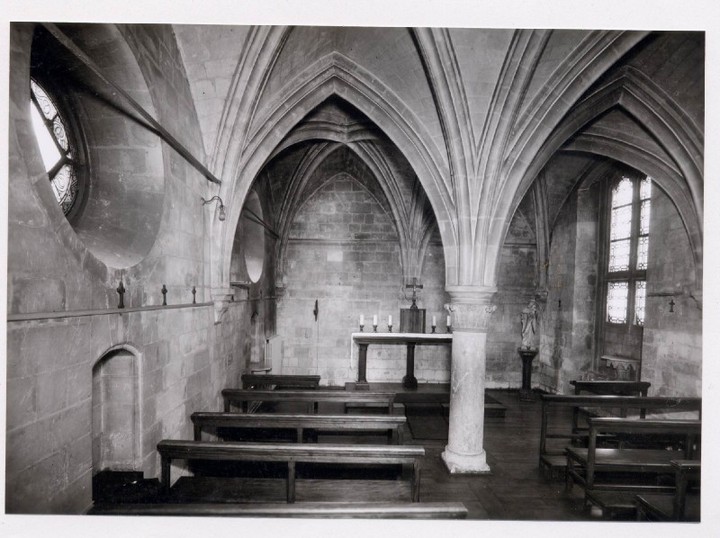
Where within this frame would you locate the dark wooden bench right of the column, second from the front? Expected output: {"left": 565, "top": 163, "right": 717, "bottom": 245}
{"left": 565, "top": 417, "right": 701, "bottom": 498}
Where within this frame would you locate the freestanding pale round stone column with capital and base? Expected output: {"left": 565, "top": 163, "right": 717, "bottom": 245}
{"left": 442, "top": 286, "right": 497, "bottom": 473}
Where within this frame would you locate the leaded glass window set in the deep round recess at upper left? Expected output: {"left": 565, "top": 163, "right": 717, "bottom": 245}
{"left": 30, "top": 79, "right": 79, "bottom": 215}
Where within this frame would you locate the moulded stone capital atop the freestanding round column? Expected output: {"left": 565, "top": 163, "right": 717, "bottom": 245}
{"left": 445, "top": 286, "right": 497, "bottom": 332}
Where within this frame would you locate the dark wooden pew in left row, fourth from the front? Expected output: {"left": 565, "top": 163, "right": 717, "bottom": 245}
{"left": 222, "top": 389, "right": 395, "bottom": 415}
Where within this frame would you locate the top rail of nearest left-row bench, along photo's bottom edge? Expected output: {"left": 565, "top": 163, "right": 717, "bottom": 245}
{"left": 88, "top": 502, "right": 468, "bottom": 519}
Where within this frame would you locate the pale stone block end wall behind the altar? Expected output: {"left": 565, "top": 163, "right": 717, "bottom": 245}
{"left": 277, "top": 174, "right": 450, "bottom": 385}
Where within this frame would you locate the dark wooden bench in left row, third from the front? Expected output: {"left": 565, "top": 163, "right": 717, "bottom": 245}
{"left": 190, "top": 412, "right": 407, "bottom": 444}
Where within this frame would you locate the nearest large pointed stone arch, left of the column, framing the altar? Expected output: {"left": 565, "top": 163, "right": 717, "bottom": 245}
{"left": 210, "top": 52, "right": 457, "bottom": 288}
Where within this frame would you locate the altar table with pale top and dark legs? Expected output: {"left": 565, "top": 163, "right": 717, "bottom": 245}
{"left": 352, "top": 332, "right": 452, "bottom": 390}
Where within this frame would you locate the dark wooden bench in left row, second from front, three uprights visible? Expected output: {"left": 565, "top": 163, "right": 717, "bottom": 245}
{"left": 157, "top": 440, "right": 425, "bottom": 503}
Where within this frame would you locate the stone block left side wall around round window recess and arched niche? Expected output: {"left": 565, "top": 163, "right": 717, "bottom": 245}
{"left": 6, "top": 24, "right": 262, "bottom": 513}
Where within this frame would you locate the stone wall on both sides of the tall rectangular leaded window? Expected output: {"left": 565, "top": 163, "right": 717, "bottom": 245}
{"left": 538, "top": 172, "right": 702, "bottom": 396}
